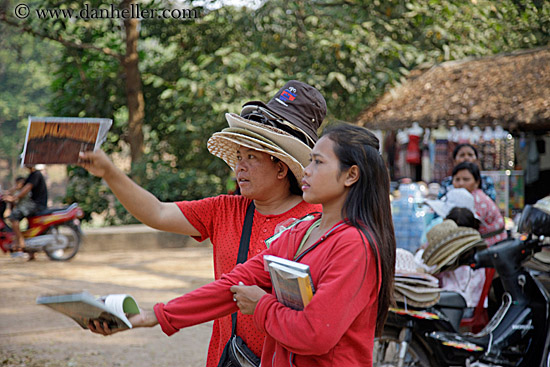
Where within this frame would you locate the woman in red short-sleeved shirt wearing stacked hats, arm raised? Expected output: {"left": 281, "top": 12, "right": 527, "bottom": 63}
{"left": 81, "top": 80, "right": 326, "bottom": 367}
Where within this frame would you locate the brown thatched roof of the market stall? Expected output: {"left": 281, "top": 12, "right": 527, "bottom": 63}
{"left": 356, "top": 48, "right": 550, "bottom": 131}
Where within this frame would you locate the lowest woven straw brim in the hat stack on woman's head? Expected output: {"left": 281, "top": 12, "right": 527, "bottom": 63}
{"left": 207, "top": 132, "right": 304, "bottom": 182}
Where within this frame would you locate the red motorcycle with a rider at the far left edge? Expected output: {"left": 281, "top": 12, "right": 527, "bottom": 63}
{"left": 0, "top": 198, "right": 84, "bottom": 261}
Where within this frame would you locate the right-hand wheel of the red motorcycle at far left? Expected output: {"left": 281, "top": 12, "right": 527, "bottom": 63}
{"left": 44, "top": 223, "right": 82, "bottom": 261}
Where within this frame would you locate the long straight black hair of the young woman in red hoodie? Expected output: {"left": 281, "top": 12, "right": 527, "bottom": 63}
{"left": 323, "top": 124, "right": 395, "bottom": 336}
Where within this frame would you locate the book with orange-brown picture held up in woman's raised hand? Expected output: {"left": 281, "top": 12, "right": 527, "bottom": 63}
{"left": 21, "top": 116, "right": 113, "bottom": 166}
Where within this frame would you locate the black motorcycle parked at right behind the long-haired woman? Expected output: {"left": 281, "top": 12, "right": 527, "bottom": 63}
{"left": 373, "top": 205, "right": 550, "bottom": 367}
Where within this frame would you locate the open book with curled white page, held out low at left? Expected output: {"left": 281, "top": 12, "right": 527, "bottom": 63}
{"left": 36, "top": 292, "right": 139, "bottom": 329}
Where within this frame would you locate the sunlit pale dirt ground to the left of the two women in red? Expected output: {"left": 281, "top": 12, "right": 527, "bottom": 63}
{"left": 0, "top": 246, "right": 213, "bottom": 367}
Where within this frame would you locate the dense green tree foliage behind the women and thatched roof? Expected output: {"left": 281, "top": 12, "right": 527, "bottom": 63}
{"left": 0, "top": 0, "right": 550, "bottom": 223}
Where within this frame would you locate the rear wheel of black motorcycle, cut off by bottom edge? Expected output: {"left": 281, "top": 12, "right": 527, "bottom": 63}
{"left": 372, "top": 326, "right": 435, "bottom": 367}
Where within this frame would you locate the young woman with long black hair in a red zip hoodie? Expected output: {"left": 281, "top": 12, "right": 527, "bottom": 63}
{"left": 90, "top": 125, "right": 395, "bottom": 367}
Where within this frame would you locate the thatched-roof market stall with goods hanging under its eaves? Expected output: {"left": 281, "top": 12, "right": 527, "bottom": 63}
{"left": 356, "top": 47, "right": 550, "bottom": 250}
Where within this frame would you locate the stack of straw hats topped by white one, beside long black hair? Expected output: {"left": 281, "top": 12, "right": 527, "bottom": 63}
{"left": 393, "top": 248, "right": 441, "bottom": 308}
